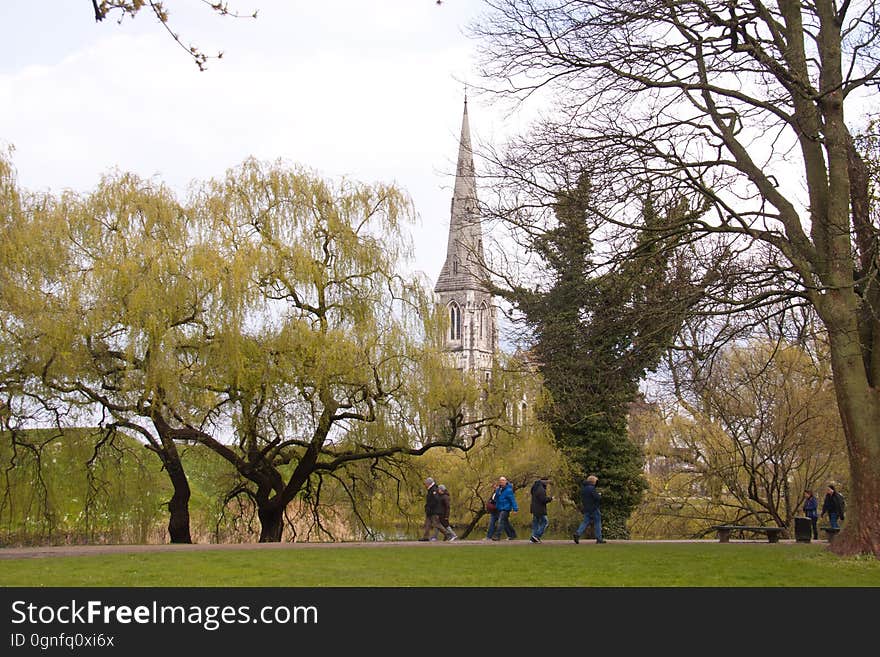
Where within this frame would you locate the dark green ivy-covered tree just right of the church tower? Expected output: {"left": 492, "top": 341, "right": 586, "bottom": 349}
{"left": 499, "top": 174, "right": 693, "bottom": 536}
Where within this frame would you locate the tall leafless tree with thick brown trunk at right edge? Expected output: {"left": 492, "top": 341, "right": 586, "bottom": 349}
{"left": 474, "top": 0, "right": 880, "bottom": 556}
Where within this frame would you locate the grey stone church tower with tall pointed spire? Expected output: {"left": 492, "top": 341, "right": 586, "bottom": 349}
{"left": 434, "top": 98, "right": 498, "bottom": 374}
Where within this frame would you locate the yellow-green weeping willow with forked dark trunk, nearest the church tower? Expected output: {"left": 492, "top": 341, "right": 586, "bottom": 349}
{"left": 183, "top": 160, "right": 497, "bottom": 542}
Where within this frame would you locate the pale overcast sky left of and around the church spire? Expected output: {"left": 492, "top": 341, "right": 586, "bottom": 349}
{"left": 0, "top": 0, "right": 524, "bottom": 282}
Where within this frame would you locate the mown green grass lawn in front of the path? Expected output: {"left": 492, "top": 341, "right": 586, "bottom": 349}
{"left": 0, "top": 542, "right": 880, "bottom": 587}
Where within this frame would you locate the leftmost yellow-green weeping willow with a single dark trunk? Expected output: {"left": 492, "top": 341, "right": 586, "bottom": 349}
{"left": 0, "top": 160, "right": 215, "bottom": 543}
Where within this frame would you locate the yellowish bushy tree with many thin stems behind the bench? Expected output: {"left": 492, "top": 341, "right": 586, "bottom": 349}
{"left": 639, "top": 336, "right": 848, "bottom": 534}
